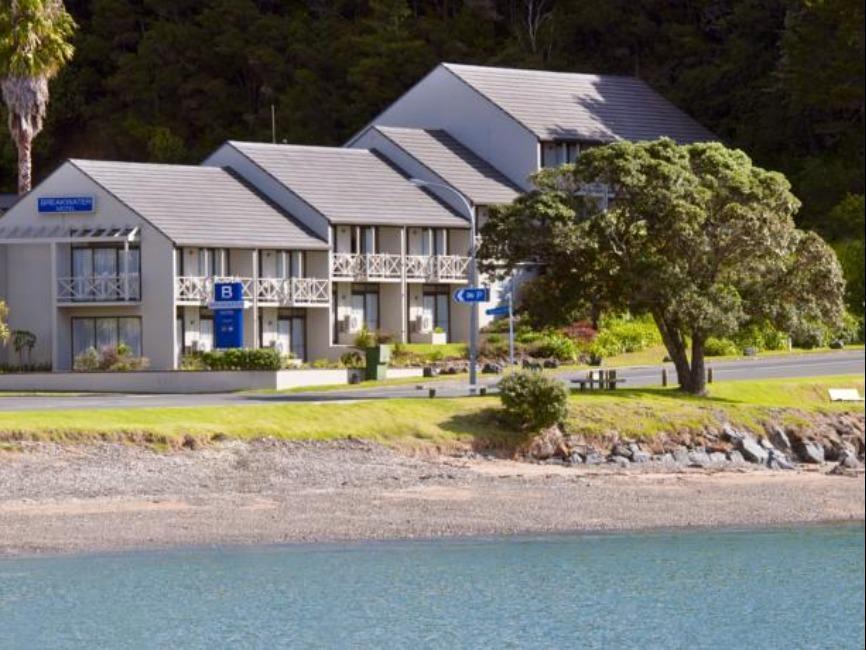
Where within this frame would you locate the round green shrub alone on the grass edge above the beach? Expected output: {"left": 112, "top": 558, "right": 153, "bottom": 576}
{"left": 499, "top": 371, "right": 568, "bottom": 431}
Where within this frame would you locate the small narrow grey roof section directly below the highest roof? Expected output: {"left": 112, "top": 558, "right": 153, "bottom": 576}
{"left": 373, "top": 126, "right": 520, "bottom": 205}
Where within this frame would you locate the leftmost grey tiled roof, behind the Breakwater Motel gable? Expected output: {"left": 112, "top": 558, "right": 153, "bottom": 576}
{"left": 69, "top": 160, "right": 327, "bottom": 249}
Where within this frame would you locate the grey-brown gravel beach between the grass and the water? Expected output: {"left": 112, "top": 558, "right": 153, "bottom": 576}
{"left": 0, "top": 440, "right": 864, "bottom": 555}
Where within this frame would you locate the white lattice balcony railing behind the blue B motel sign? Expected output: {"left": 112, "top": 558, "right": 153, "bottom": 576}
{"left": 175, "top": 276, "right": 331, "bottom": 307}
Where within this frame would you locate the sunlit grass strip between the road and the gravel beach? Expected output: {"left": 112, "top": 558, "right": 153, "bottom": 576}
{"left": 0, "top": 375, "right": 864, "bottom": 448}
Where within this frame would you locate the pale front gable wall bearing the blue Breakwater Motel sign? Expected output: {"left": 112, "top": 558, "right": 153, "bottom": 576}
{"left": 0, "top": 163, "right": 175, "bottom": 370}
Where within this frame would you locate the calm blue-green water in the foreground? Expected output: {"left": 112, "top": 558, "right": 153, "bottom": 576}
{"left": 0, "top": 526, "right": 864, "bottom": 650}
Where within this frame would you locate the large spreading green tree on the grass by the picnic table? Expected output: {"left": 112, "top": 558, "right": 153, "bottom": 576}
{"left": 480, "top": 139, "right": 845, "bottom": 394}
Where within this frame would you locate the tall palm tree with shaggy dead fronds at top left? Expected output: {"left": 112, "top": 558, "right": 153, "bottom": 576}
{"left": 0, "top": 0, "right": 75, "bottom": 194}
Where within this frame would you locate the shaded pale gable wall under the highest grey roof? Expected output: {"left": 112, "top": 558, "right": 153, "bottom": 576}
{"left": 347, "top": 66, "right": 540, "bottom": 190}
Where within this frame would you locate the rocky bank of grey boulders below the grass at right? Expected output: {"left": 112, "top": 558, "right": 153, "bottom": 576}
{"left": 502, "top": 413, "right": 866, "bottom": 474}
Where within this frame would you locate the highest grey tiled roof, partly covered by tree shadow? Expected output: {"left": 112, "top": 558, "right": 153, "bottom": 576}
{"left": 442, "top": 63, "right": 718, "bottom": 143}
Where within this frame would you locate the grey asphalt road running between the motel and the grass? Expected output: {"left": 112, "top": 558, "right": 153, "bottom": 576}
{"left": 0, "top": 350, "right": 866, "bottom": 411}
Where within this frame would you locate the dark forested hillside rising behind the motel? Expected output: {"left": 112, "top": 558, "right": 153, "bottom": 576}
{"left": 0, "top": 0, "right": 864, "bottom": 246}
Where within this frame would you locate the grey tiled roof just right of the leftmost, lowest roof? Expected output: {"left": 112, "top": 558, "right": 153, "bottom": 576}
{"left": 228, "top": 142, "right": 467, "bottom": 227}
